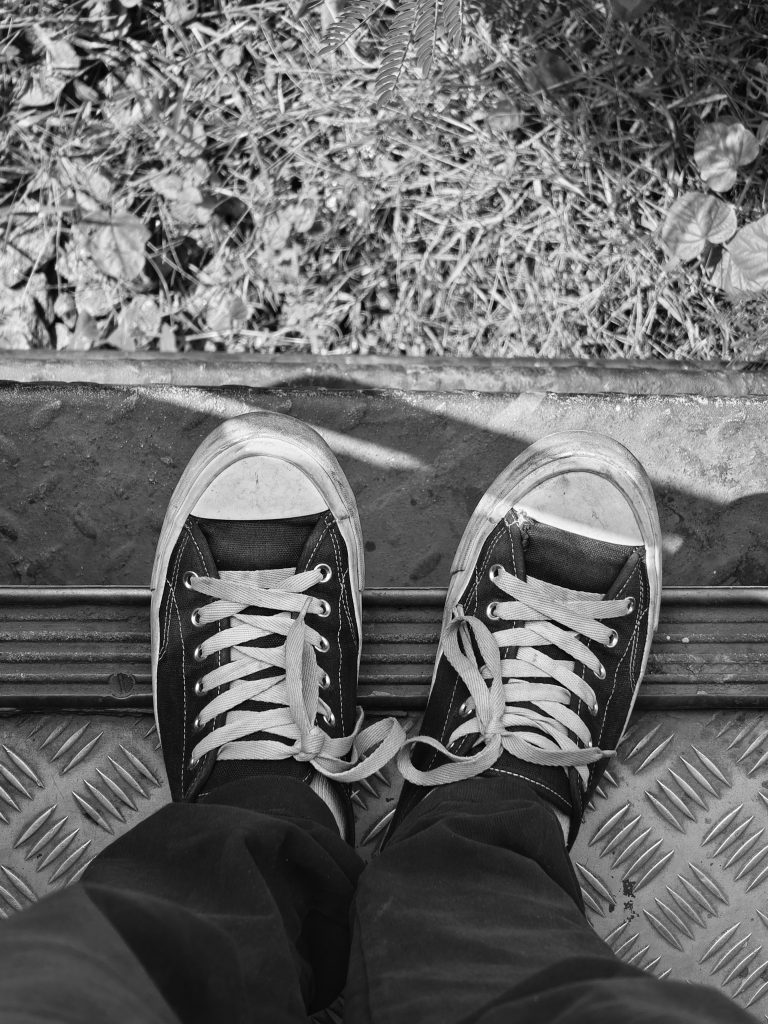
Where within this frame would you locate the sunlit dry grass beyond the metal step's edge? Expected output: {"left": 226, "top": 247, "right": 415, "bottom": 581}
{"left": 0, "top": 0, "right": 768, "bottom": 364}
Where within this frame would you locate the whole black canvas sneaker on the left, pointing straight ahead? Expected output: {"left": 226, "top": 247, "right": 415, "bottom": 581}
{"left": 146, "top": 413, "right": 406, "bottom": 842}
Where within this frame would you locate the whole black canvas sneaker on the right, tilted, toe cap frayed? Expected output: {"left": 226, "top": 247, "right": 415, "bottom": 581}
{"left": 388, "top": 431, "right": 662, "bottom": 849}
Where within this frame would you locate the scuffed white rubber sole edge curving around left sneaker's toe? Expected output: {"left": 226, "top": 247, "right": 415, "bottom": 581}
{"left": 150, "top": 412, "right": 366, "bottom": 734}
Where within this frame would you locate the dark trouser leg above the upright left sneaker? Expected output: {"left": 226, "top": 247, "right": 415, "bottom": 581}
{"left": 0, "top": 776, "right": 362, "bottom": 1024}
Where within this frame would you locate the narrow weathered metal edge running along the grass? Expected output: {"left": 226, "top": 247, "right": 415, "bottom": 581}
{"left": 0, "top": 350, "right": 768, "bottom": 397}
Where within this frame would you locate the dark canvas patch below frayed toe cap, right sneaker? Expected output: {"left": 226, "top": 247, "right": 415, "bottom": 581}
{"left": 519, "top": 517, "right": 634, "bottom": 594}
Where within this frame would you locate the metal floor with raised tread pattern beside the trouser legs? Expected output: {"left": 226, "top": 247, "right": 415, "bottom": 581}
{"left": 0, "top": 711, "right": 768, "bottom": 1021}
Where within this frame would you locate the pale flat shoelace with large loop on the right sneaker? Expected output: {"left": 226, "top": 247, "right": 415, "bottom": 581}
{"left": 397, "top": 565, "right": 635, "bottom": 787}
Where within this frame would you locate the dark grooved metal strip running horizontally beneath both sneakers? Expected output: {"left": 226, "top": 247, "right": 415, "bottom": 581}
{"left": 0, "top": 587, "right": 768, "bottom": 711}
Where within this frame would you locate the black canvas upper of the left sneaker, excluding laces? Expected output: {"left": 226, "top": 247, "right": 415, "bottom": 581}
{"left": 157, "top": 511, "right": 360, "bottom": 834}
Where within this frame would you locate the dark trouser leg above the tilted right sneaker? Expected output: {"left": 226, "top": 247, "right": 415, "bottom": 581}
{"left": 346, "top": 778, "right": 752, "bottom": 1024}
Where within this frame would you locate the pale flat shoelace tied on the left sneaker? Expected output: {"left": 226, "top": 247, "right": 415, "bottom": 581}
{"left": 186, "top": 565, "right": 406, "bottom": 782}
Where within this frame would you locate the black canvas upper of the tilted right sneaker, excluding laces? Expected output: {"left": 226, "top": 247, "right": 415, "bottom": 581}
{"left": 389, "top": 509, "right": 650, "bottom": 845}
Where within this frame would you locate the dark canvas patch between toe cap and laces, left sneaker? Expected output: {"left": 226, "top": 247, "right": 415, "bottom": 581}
{"left": 191, "top": 513, "right": 322, "bottom": 573}
